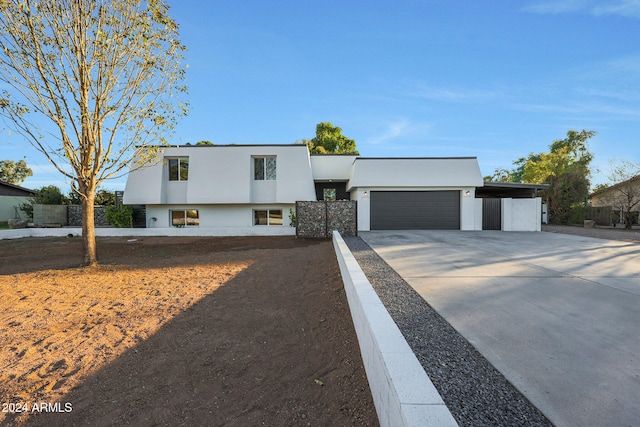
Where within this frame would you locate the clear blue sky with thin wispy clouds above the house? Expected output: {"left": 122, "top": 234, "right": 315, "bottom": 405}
{"left": 0, "top": 0, "right": 640, "bottom": 190}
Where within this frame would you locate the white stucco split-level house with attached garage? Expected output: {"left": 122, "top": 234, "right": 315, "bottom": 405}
{"left": 123, "top": 144, "right": 540, "bottom": 235}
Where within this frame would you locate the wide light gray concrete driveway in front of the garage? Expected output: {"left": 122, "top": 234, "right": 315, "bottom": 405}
{"left": 360, "top": 231, "right": 640, "bottom": 426}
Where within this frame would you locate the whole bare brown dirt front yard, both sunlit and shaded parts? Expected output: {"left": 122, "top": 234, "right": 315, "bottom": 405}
{"left": 0, "top": 237, "right": 378, "bottom": 426}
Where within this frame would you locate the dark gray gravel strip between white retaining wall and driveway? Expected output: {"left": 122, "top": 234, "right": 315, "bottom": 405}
{"left": 344, "top": 237, "right": 553, "bottom": 427}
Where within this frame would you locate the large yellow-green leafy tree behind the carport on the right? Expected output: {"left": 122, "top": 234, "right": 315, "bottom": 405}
{"left": 512, "top": 130, "right": 596, "bottom": 223}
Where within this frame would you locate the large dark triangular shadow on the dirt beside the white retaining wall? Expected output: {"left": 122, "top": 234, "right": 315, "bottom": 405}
{"left": 5, "top": 241, "right": 377, "bottom": 426}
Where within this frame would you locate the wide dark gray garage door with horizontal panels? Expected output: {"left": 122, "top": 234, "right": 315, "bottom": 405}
{"left": 371, "top": 191, "right": 460, "bottom": 230}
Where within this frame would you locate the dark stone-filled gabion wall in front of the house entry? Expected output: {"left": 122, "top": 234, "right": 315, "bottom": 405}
{"left": 296, "top": 200, "right": 358, "bottom": 239}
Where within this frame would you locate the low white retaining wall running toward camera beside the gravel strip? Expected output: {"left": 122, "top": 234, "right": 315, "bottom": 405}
{"left": 333, "top": 231, "right": 458, "bottom": 427}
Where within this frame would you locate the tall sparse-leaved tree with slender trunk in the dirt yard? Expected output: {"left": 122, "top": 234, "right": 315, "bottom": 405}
{"left": 0, "top": 0, "right": 186, "bottom": 265}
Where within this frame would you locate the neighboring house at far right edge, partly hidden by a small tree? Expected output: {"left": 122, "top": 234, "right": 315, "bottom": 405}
{"left": 590, "top": 175, "right": 640, "bottom": 224}
